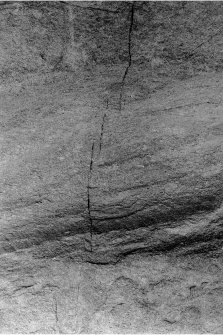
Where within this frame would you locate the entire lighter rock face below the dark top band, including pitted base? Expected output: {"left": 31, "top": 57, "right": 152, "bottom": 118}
{"left": 0, "top": 68, "right": 223, "bottom": 333}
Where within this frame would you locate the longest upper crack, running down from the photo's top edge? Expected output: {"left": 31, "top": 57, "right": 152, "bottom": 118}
{"left": 119, "top": 1, "right": 135, "bottom": 111}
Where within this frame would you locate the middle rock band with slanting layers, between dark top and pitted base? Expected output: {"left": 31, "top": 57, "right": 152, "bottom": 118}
{"left": 1, "top": 69, "right": 223, "bottom": 261}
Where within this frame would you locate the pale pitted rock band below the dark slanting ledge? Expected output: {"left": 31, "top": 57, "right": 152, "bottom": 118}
{"left": 0, "top": 251, "right": 223, "bottom": 334}
